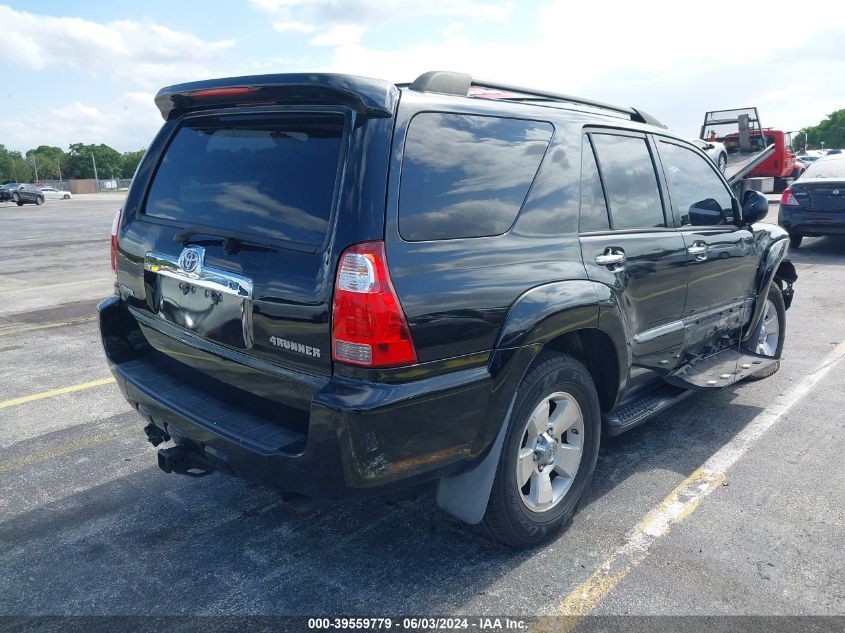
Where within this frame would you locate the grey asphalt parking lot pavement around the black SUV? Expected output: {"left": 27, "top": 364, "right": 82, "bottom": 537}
{"left": 0, "top": 194, "right": 845, "bottom": 627}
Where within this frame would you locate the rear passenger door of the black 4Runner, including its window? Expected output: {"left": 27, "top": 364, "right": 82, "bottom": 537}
{"left": 579, "top": 131, "right": 687, "bottom": 390}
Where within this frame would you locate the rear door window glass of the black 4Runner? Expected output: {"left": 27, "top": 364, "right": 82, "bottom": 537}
{"left": 592, "top": 134, "right": 666, "bottom": 229}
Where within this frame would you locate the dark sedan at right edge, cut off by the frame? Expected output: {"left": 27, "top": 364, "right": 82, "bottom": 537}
{"left": 778, "top": 154, "right": 845, "bottom": 248}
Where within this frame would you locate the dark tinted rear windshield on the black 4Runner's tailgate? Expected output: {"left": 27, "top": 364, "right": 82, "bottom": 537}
{"left": 145, "top": 113, "right": 344, "bottom": 247}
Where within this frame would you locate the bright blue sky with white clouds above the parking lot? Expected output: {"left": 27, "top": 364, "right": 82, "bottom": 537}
{"left": 0, "top": 0, "right": 845, "bottom": 151}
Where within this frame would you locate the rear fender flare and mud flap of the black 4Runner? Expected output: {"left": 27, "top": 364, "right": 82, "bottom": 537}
{"left": 436, "top": 279, "right": 617, "bottom": 525}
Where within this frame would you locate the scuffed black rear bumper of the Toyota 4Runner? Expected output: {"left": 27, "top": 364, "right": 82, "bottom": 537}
{"left": 98, "top": 296, "right": 492, "bottom": 499}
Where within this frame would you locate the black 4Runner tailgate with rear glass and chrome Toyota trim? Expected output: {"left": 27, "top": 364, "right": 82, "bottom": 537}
{"left": 125, "top": 109, "right": 349, "bottom": 375}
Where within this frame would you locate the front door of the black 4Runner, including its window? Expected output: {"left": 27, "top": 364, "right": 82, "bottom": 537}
{"left": 656, "top": 138, "right": 757, "bottom": 356}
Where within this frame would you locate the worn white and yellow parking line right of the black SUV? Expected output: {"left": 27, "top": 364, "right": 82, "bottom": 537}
{"left": 537, "top": 341, "right": 845, "bottom": 631}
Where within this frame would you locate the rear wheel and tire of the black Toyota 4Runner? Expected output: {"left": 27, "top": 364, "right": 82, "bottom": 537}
{"left": 480, "top": 352, "right": 601, "bottom": 547}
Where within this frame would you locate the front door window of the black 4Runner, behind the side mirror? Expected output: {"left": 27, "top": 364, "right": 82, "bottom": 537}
{"left": 660, "top": 141, "right": 734, "bottom": 226}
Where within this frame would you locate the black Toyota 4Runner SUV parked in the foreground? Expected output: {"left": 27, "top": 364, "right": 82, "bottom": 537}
{"left": 99, "top": 72, "right": 796, "bottom": 545}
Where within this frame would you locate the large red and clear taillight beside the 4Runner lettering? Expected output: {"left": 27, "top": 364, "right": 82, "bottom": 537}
{"left": 332, "top": 242, "right": 417, "bottom": 367}
